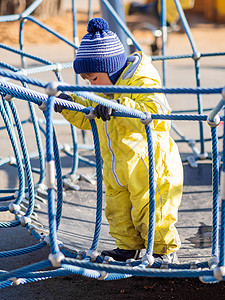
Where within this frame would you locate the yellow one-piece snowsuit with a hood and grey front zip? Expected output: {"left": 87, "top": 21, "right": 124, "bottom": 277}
{"left": 62, "top": 52, "right": 183, "bottom": 254}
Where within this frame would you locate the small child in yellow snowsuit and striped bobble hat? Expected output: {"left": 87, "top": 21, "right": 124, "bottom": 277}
{"left": 55, "top": 18, "right": 183, "bottom": 262}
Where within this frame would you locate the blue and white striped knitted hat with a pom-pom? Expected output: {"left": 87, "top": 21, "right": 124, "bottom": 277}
{"left": 73, "top": 18, "right": 127, "bottom": 75}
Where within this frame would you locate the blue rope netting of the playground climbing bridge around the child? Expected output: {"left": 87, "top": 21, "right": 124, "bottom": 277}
{"left": 0, "top": 0, "right": 225, "bottom": 288}
